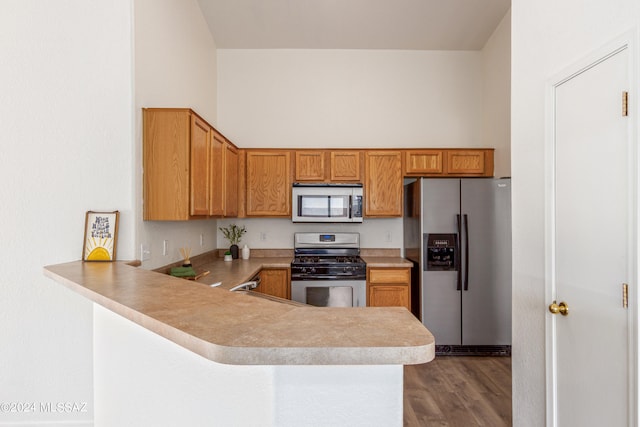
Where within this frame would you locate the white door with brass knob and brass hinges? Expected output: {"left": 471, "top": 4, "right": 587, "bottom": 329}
{"left": 547, "top": 47, "right": 635, "bottom": 427}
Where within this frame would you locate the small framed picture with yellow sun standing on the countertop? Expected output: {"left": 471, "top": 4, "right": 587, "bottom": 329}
{"left": 82, "top": 211, "right": 120, "bottom": 261}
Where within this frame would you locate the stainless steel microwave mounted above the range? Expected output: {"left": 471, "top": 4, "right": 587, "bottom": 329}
{"left": 291, "top": 183, "right": 362, "bottom": 222}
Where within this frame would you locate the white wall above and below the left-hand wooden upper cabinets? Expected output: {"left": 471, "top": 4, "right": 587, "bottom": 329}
{"left": 134, "top": 0, "right": 217, "bottom": 268}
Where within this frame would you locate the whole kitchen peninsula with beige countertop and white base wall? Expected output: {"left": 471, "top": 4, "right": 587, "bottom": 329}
{"left": 44, "top": 259, "right": 435, "bottom": 426}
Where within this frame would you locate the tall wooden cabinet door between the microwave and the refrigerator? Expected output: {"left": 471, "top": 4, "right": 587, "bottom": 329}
{"left": 364, "top": 151, "right": 403, "bottom": 217}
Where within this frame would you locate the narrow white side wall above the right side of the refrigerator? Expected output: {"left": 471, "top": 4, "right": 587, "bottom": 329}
{"left": 482, "top": 11, "right": 511, "bottom": 177}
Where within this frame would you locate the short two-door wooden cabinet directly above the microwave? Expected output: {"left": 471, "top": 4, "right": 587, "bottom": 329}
{"left": 294, "top": 150, "right": 362, "bottom": 182}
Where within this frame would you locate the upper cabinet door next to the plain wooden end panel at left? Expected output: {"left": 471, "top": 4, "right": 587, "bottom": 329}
{"left": 190, "top": 114, "right": 211, "bottom": 216}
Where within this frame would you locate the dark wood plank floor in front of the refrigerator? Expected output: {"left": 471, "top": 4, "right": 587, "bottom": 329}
{"left": 404, "top": 356, "right": 511, "bottom": 427}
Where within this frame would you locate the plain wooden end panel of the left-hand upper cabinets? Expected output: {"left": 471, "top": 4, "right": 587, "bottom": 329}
{"left": 142, "top": 109, "right": 191, "bottom": 221}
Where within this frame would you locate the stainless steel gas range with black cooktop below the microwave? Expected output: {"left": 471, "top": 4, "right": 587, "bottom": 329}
{"left": 291, "top": 233, "right": 367, "bottom": 307}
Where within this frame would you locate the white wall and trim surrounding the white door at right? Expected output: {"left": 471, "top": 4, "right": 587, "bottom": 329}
{"left": 511, "top": 0, "right": 640, "bottom": 426}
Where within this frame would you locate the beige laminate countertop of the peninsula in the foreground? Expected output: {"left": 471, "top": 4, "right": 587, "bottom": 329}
{"left": 44, "top": 257, "right": 435, "bottom": 365}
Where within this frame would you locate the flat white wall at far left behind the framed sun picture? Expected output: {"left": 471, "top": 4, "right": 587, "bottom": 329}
{"left": 0, "top": 0, "right": 135, "bottom": 425}
